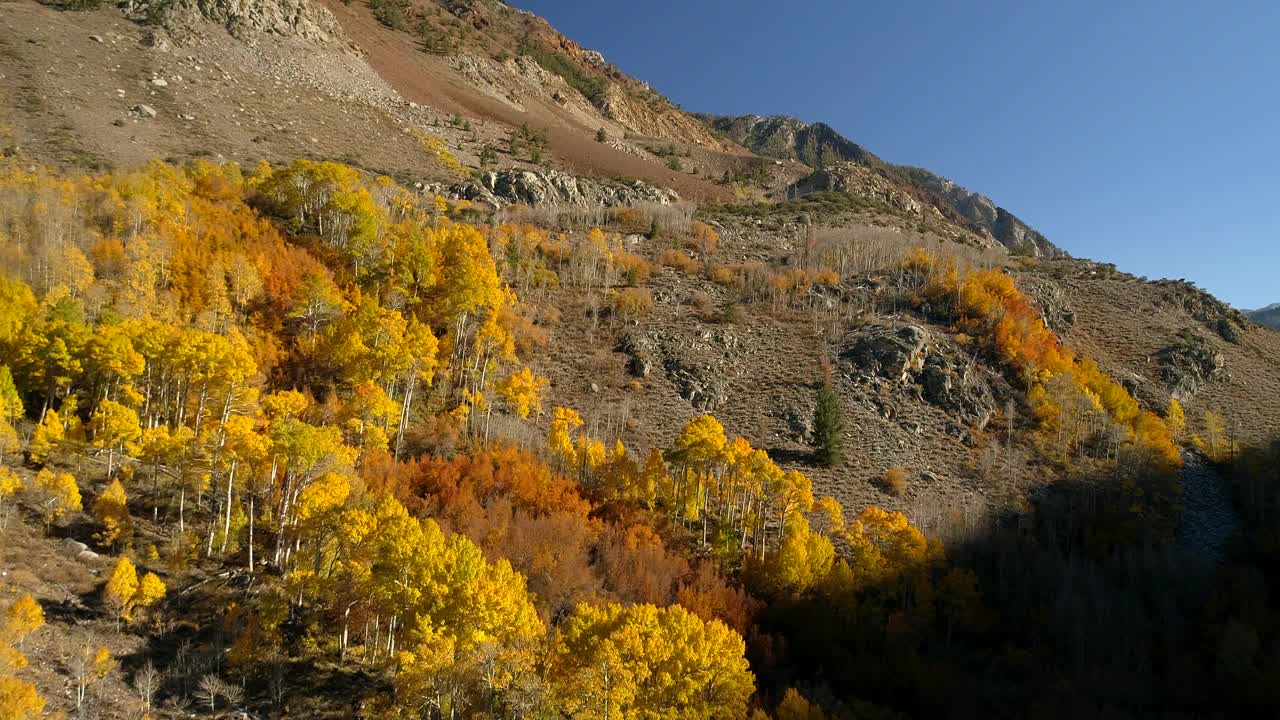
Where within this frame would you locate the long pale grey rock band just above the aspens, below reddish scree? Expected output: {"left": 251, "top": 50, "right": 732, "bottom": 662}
{"left": 445, "top": 169, "right": 680, "bottom": 208}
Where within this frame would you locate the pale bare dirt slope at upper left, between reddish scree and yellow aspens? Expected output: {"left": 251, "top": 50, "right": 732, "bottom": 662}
{"left": 0, "top": 1, "right": 483, "bottom": 178}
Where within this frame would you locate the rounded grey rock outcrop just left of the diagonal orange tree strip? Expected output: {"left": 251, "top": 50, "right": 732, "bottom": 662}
{"left": 844, "top": 325, "right": 996, "bottom": 429}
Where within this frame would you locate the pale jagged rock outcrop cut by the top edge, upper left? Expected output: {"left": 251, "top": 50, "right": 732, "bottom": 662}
{"left": 123, "top": 0, "right": 346, "bottom": 45}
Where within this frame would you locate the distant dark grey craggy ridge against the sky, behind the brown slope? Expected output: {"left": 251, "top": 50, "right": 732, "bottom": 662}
{"left": 699, "top": 114, "right": 1062, "bottom": 258}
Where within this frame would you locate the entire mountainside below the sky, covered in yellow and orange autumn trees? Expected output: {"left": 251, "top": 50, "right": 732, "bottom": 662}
{"left": 0, "top": 0, "right": 1280, "bottom": 720}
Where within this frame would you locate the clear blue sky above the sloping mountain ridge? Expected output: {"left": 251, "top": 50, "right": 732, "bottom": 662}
{"left": 515, "top": 0, "right": 1280, "bottom": 307}
